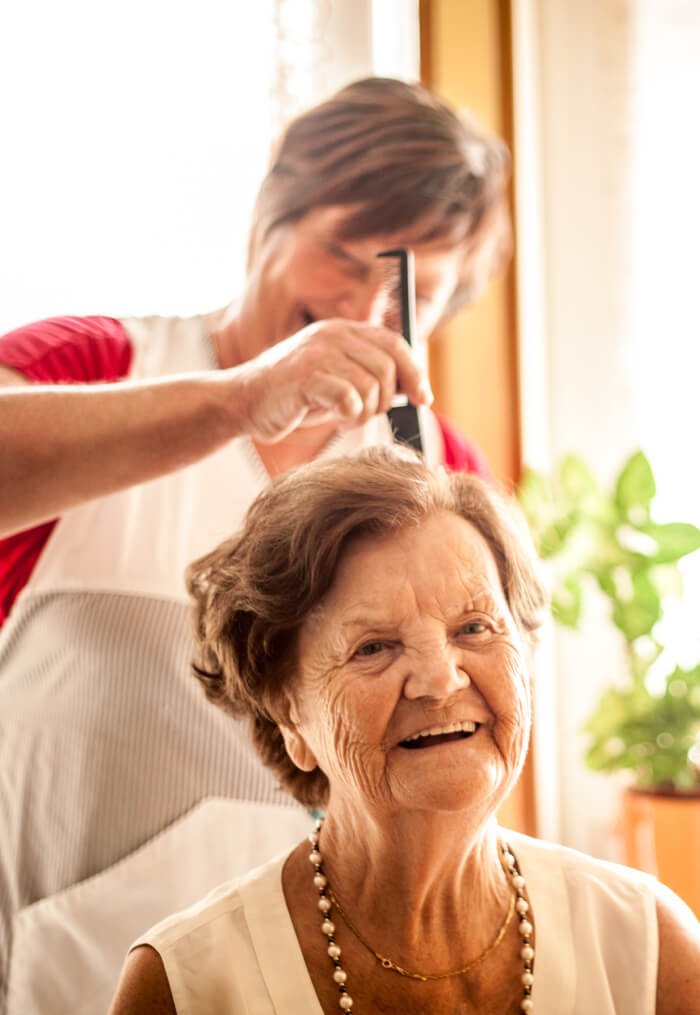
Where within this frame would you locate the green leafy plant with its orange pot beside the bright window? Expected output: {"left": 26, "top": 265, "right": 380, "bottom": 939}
{"left": 517, "top": 452, "right": 700, "bottom": 915}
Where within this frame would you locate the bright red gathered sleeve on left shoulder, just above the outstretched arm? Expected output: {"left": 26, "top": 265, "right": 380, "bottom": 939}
{"left": 0, "top": 317, "right": 132, "bottom": 384}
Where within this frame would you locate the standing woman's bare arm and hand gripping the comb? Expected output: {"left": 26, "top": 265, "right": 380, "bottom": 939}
{"left": 0, "top": 320, "right": 431, "bottom": 535}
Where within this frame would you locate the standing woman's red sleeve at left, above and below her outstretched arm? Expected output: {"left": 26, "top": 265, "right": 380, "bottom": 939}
{"left": 0, "top": 317, "right": 132, "bottom": 625}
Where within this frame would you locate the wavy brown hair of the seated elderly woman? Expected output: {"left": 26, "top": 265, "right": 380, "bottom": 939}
{"left": 188, "top": 447, "right": 546, "bottom": 806}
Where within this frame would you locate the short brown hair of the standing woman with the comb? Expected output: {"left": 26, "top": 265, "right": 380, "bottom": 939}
{"left": 249, "top": 77, "right": 510, "bottom": 314}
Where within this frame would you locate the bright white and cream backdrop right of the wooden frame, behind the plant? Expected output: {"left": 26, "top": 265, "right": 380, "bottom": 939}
{"left": 513, "top": 0, "right": 700, "bottom": 859}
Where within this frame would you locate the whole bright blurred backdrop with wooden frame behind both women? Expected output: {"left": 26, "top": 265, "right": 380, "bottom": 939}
{"left": 0, "top": 0, "right": 700, "bottom": 901}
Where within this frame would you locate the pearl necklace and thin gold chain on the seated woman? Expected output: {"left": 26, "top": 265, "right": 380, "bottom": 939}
{"left": 308, "top": 818, "right": 535, "bottom": 1015}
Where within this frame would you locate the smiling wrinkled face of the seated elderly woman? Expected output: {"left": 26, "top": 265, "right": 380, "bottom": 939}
{"left": 283, "top": 511, "right": 531, "bottom": 816}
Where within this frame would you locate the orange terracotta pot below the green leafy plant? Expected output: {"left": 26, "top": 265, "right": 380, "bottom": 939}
{"left": 620, "top": 789, "right": 700, "bottom": 919}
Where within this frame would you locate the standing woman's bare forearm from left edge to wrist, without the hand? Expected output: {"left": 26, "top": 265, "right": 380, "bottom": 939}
{"left": 0, "top": 371, "right": 246, "bottom": 535}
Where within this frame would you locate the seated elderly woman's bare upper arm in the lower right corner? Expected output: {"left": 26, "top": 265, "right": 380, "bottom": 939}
{"left": 656, "top": 884, "right": 700, "bottom": 1015}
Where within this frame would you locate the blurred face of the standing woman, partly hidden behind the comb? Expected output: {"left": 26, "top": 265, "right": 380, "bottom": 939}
{"left": 241, "top": 207, "right": 463, "bottom": 355}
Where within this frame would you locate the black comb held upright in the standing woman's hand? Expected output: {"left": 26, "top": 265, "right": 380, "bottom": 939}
{"left": 376, "top": 247, "right": 423, "bottom": 452}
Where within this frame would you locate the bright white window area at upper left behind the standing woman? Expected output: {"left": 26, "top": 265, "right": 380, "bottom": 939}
{"left": 0, "top": 0, "right": 418, "bottom": 333}
